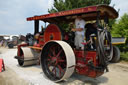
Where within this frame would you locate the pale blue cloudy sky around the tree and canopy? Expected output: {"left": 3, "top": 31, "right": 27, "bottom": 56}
{"left": 0, "top": 0, "right": 128, "bottom": 35}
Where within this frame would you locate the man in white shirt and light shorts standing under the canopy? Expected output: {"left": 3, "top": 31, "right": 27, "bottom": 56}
{"left": 72, "top": 15, "right": 85, "bottom": 50}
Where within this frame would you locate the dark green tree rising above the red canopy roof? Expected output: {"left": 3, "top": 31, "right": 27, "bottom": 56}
{"left": 48, "top": 0, "right": 111, "bottom": 13}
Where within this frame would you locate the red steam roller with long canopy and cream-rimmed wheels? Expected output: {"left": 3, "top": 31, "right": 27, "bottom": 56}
{"left": 15, "top": 5, "right": 118, "bottom": 82}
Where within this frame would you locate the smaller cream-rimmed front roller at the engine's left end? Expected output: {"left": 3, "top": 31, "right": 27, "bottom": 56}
{"left": 15, "top": 47, "right": 39, "bottom": 66}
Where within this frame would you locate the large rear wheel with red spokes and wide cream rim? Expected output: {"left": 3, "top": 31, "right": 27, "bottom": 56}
{"left": 41, "top": 41, "right": 76, "bottom": 82}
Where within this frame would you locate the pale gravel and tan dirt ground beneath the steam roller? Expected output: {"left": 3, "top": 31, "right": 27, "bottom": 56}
{"left": 0, "top": 48, "right": 128, "bottom": 85}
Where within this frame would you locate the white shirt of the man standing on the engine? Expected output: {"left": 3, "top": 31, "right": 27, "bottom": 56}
{"left": 75, "top": 18, "right": 85, "bottom": 36}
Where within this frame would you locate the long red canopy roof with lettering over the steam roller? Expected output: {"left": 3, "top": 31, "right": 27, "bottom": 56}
{"left": 27, "top": 5, "right": 118, "bottom": 23}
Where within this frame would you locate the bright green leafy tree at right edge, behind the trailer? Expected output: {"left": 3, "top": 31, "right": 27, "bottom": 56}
{"left": 111, "top": 14, "right": 128, "bottom": 52}
